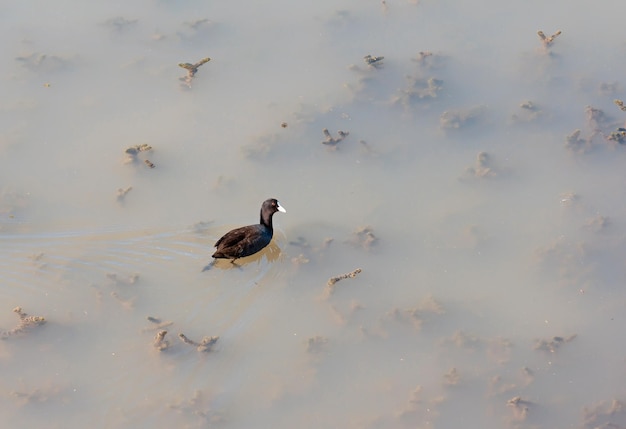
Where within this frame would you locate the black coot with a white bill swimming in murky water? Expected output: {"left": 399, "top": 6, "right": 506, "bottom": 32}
{"left": 202, "top": 198, "right": 287, "bottom": 271}
